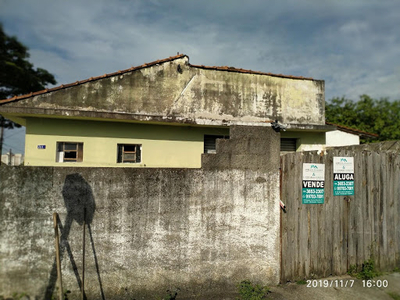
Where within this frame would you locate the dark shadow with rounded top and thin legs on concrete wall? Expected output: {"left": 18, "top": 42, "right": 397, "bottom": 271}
{"left": 45, "top": 173, "right": 105, "bottom": 299}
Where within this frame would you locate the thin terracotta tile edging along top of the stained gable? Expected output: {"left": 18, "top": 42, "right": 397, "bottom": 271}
{"left": 0, "top": 54, "right": 314, "bottom": 105}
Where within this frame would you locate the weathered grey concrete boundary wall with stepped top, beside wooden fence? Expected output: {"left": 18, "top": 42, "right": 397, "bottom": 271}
{"left": 0, "top": 127, "right": 280, "bottom": 299}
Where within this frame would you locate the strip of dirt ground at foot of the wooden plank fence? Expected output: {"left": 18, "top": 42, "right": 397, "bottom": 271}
{"left": 268, "top": 273, "right": 400, "bottom": 300}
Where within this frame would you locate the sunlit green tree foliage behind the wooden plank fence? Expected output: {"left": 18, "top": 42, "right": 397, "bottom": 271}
{"left": 325, "top": 95, "right": 400, "bottom": 142}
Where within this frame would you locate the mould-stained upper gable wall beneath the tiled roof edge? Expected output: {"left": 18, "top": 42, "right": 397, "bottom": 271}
{"left": 1, "top": 56, "right": 325, "bottom": 125}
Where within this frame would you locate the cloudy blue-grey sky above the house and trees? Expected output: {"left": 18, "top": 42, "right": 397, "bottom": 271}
{"left": 0, "top": 0, "right": 400, "bottom": 152}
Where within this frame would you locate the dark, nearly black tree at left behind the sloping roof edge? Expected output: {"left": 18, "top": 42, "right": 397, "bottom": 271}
{"left": 0, "top": 24, "right": 56, "bottom": 157}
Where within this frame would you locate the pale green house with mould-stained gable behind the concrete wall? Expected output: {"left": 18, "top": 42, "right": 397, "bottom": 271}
{"left": 0, "top": 54, "right": 335, "bottom": 168}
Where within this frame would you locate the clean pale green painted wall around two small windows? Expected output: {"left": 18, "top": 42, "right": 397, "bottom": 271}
{"left": 25, "top": 118, "right": 229, "bottom": 168}
